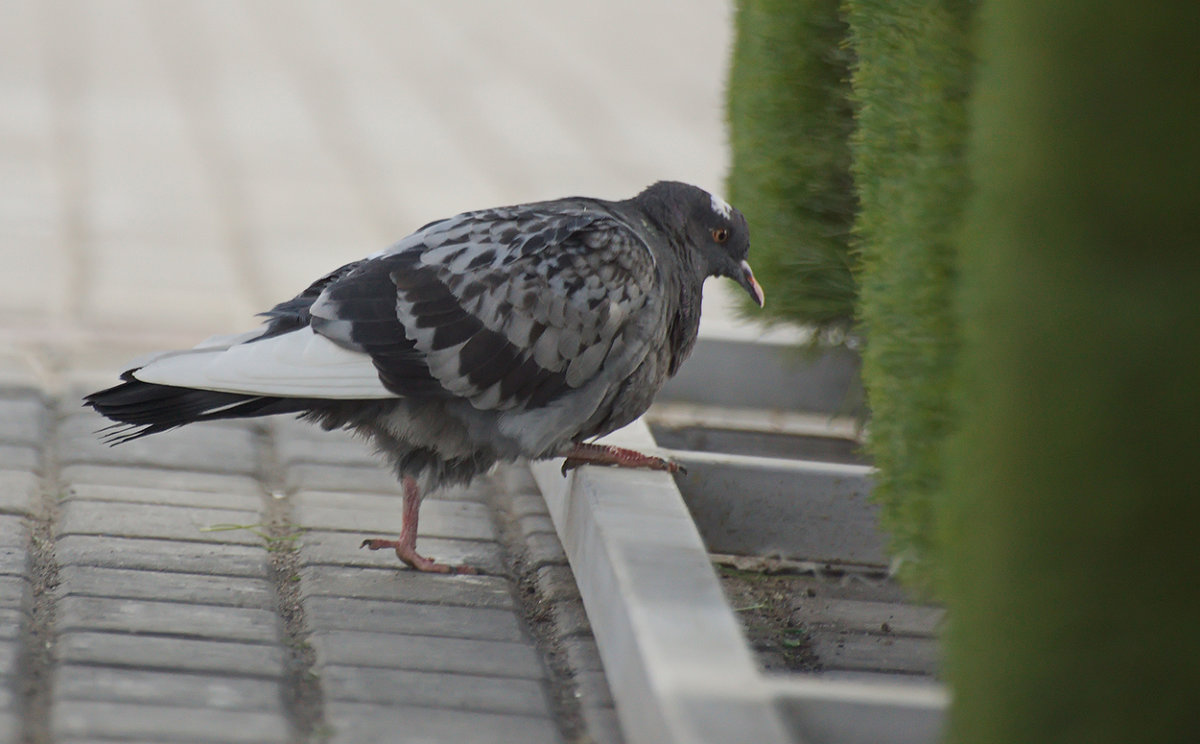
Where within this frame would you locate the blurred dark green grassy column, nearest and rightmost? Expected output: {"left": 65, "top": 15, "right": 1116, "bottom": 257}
{"left": 947, "top": 0, "right": 1200, "bottom": 744}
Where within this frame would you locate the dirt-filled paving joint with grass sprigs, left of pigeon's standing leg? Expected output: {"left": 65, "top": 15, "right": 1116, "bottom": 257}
{"left": 256, "top": 425, "right": 330, "bottom": 743}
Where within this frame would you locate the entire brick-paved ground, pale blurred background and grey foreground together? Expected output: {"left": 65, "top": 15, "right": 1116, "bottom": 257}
{"left": 0, "top": 0, "right": 728, "bottom": 743}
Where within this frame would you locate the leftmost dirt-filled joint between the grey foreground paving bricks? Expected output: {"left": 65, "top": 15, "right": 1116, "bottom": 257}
{"left": 16, "top": 391, "right": 62, "bottom": 744}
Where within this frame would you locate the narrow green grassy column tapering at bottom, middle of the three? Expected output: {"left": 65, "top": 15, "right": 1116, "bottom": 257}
{"left": 846, "top": 0, "right": 973, "bottom": 588}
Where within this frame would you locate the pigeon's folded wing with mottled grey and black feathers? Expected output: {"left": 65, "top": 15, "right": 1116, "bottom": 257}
{"left": 311, "top": 203, "right": 662, "bottom": 409}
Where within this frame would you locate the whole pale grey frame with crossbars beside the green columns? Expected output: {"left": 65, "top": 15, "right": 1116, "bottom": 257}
{"left": 533, "top": 338, "right": 947, "bottom": 744}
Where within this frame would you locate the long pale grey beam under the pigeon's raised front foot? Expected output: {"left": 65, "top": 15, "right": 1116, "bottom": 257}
{"left": 533, "top": 421, "right": 791, "bottom": 744}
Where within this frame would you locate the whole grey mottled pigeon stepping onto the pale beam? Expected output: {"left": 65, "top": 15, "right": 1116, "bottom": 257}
{"left": 84, "top": 181, "right": 763, "bottom": 574}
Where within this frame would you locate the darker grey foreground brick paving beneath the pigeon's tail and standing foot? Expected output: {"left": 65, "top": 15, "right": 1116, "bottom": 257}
{"left": 0, "top": 381, "right": 619, "bottom": 742}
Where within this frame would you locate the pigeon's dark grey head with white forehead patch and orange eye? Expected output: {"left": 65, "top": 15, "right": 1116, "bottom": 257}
{"left": 635, "top": 181, "right": 763, "bottom": 307}
